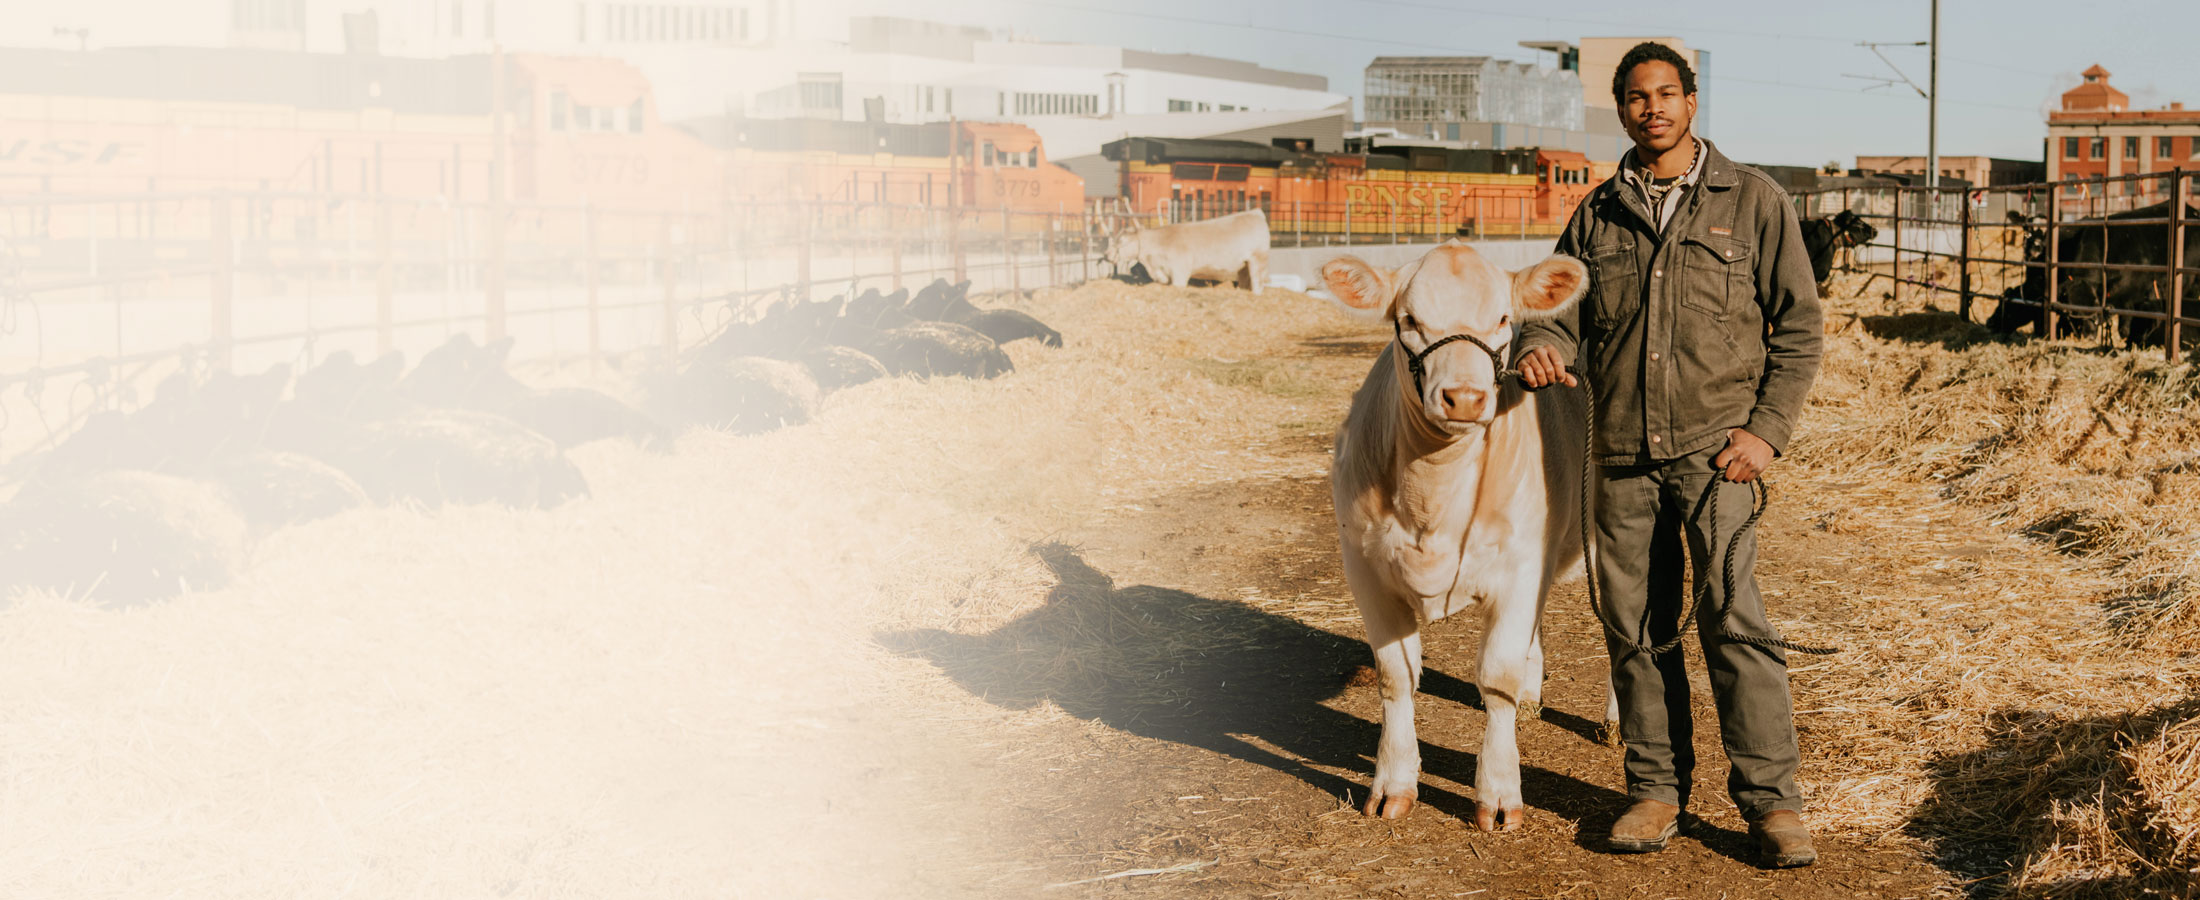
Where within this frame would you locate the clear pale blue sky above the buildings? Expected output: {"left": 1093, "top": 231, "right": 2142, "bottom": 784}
{"left": 884, "top": 0, "right": 2200, "bottom": 167}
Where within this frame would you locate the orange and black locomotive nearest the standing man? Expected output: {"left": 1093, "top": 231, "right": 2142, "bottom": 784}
{"left": 1100, "top": 136, "right": 1591, "bottom": 235}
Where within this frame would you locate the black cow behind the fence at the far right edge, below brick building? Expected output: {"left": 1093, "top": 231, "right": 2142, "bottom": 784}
{"left": 1987, "top": 200, "right": 2200, "bottom": 345}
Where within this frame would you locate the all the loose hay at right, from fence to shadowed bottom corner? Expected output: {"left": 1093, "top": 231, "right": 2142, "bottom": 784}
{"left": 1793, "top": 286, "right": 2200, "bottom": 898}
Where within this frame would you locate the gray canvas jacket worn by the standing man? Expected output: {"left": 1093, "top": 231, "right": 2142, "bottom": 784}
{"left": 1520, "top": 143, "right": 1824, "bottom": 464}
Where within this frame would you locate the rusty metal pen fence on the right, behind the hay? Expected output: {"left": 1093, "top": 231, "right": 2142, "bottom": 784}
{"left": 1795, "top": 169, "right": 2200, "bottom": 361}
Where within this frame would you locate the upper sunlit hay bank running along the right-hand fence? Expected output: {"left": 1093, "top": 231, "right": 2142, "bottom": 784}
{"left": 1800, "top": 337, "right": 2200, "bottom": 647}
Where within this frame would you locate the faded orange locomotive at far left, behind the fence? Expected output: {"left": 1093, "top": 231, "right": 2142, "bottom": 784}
{"left": 0, "top": 46, "right": 743, "bottom": 266}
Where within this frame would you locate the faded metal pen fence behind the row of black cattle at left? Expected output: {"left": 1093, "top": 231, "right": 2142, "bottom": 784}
{"left": 0, "top": 194, "right": 1104, "bottom": 456}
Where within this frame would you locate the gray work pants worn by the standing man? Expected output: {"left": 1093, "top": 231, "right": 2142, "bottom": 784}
{"left": 1595, "top": 442, "right": 1802, "bottom": 821}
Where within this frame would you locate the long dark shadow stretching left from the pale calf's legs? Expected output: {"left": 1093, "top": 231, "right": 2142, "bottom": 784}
{"left": 878, "top": 544, "right": 1617, "bottom": 821}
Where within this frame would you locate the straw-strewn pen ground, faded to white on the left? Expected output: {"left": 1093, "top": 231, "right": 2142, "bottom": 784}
{"left": 0, "top": 262, "right": 2173, "bottom": 900}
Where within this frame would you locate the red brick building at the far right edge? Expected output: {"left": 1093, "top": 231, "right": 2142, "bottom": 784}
{"left": 2048, "top": 66, "right": 2200, "bottom": 196}
